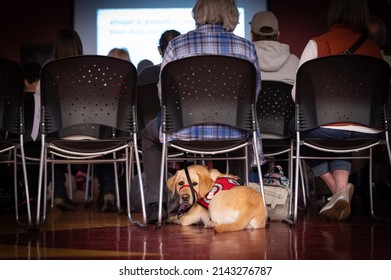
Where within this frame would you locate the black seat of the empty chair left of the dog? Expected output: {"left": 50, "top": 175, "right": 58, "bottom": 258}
{"left": 50, "top": 139, "right": 128, "bottom": 154}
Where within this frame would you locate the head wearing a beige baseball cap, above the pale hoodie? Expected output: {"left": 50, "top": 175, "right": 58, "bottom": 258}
{"left": 250, "top": 11, "right": 280, "bottom": 41}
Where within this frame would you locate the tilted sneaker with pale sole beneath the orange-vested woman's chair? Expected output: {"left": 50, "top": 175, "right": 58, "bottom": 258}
{"left": 319, "top": 190, "right": 350, "bottom": 220}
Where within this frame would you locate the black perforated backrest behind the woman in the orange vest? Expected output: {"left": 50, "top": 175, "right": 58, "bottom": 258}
{"left": 295, "top": 55, "right": 390, "bottom": 130}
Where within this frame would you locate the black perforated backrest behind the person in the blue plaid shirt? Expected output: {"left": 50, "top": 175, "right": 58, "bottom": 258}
{"left": 161, "top": 55, "right": 256, "bottom": 132}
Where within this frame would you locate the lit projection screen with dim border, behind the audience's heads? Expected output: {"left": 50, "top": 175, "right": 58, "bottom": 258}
{"left": 74, "top": 0, "right": 267, "bottom": 66}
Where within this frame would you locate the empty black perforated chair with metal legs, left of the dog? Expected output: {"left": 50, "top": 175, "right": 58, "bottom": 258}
{"left": 37, "top": 55, "right": 146, "bottom": 227}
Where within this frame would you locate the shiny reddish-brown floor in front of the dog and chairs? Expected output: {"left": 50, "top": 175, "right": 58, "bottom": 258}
{"left": 0, "top": 192, "right": 391, "bottom": 260}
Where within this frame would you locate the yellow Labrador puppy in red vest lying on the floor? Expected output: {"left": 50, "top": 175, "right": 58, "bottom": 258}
{"left": 167, "top": 165, "right": 266, "bottom": 232}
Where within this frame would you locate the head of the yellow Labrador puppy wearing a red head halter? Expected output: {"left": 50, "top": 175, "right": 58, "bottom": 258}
{"left": 167, "top": 165, "right": 214, "bottom": 204}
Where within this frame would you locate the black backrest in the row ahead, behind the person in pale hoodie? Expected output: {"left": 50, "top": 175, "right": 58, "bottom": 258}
{"left": 257, "top": 81, "right": 295, "bottom": 138}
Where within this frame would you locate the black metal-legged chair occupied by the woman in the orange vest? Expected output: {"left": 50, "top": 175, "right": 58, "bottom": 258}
{"left": 292, "top": 55, "right": 391, "bottom": 223}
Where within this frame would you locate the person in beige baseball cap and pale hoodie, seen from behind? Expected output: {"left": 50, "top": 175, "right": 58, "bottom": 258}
{"left": 250, "top": 11, "right": 299, "bottom": 84}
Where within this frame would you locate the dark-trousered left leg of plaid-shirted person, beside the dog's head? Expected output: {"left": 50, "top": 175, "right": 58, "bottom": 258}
{"left": 141, "top": 119, "right": 167, "bottom": 224}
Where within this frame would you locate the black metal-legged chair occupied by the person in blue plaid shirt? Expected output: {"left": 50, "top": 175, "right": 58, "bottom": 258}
{"left": 158, "top": 55, "right": 266, "bottom": 227}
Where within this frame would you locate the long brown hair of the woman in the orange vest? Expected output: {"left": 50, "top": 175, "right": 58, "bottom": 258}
{"left": 328, "top": 0, "right": 369, "bottom": 34}
